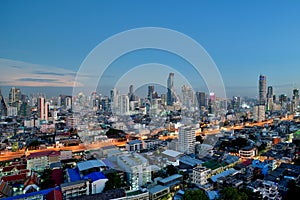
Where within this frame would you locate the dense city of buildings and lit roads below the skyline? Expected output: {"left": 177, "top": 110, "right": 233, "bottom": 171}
{"left": 0, "top": 73, "right": 300, "bottom": 200}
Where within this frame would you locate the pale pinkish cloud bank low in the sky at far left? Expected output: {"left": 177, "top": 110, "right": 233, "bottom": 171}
{"left": 0, "top": 58, "right": 81, "bottom": 87}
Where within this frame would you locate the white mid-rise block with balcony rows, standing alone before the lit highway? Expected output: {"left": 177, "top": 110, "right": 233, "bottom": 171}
{"left": 178, "top": 126, "right": 196, "bottom": 154}
